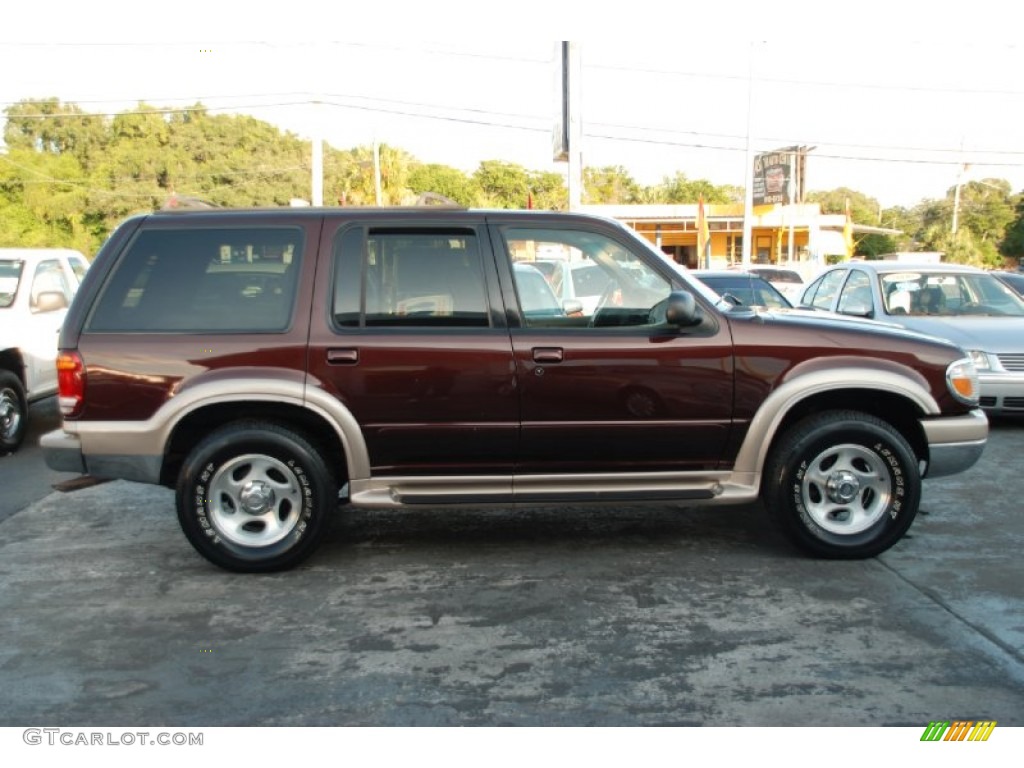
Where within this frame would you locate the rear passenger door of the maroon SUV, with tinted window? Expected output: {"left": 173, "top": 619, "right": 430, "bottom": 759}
{"left": 309, "top": 215, "right": 519, "bottom": 476}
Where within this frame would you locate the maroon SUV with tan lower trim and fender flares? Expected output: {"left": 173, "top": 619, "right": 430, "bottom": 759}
{"left": 42, "top": 208, "right": 988, "bottom": 571}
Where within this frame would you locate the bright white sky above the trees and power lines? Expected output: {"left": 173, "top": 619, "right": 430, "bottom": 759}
{"left": 6, "top": 0, "right": 1024, "bottom": 207}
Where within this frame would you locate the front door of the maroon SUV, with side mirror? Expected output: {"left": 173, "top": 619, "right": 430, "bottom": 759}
{"left": 488, "top": 216, "right": 733, "bottom": 474}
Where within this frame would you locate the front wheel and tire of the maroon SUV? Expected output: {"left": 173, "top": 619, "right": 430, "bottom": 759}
{"left": 763, "top": 411, "right": 921, "bottom": 559}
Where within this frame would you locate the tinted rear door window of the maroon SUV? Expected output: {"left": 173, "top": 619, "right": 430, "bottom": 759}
{"left": 332, "top": 228, "right": 490, "bottom": 328}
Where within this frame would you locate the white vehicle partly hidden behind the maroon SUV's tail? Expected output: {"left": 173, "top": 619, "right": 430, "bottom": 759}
{"left": 0, "top": 248, "right": 89, "bottom": 455}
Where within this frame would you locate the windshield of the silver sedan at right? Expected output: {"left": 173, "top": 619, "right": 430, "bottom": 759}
{"left": 881, "top": 271, "right": 1024, "bottom": 317}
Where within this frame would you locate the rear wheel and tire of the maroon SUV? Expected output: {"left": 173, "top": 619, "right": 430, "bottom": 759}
{"left": 177, "top": 421, "right": 338, "bottom": 573}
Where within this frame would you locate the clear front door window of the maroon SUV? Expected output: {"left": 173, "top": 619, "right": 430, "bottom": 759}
{"left": 502, "top": 226, "right": 672, "bottom": 328}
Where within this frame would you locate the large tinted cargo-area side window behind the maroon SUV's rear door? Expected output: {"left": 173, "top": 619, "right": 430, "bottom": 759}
{"left": 87, "top": 227, "right": 302, "bottom": 333}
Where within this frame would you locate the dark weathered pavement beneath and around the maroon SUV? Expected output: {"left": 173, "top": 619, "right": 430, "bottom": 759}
{"left": 0, "top": 424, "right": 1024, "bottom": 727}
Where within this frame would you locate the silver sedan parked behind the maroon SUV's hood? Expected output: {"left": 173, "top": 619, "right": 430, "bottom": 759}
{"left": 803, "top": 261, "right": 1024, "bottom": 414}
